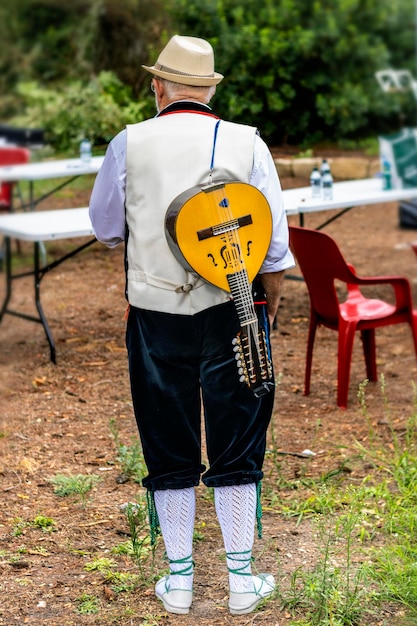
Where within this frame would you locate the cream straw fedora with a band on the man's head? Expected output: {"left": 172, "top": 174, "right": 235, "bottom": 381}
{"left": 142, "top": 35, "right": 223, "bottom": 87}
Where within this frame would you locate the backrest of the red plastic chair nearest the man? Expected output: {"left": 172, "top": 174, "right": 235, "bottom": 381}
{"left": 290, "top": 226, "right": 353, "bottom": 325}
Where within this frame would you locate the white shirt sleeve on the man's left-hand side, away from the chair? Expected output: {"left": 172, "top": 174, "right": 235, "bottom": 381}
{"left": 89, "top": 130, "right": 126, "bottom": 248}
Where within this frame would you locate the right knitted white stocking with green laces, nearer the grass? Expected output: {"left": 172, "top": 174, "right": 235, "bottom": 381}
{"left": 214, "top": 483, "right": 257, "bottom": 593}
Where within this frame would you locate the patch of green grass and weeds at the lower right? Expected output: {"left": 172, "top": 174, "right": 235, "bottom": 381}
{"left": 268, "top": 377, "right": 417, "bottom": 626}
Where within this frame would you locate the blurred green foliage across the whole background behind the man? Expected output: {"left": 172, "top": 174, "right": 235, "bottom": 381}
{"left": 0, "top": 0, "right": 416, "bottom": 149}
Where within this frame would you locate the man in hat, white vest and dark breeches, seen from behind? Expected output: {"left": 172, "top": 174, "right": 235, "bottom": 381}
{"left": 90, "top": 35, "right": 294, "bottom": 615}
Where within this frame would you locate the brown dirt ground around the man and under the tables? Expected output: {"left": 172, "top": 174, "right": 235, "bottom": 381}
{"left": 0, "top": 167, "right": 417, "bottom": 626}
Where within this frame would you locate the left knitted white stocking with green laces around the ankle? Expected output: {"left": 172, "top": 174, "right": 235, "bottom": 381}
{"left": 154, "top": 487, "right": 195, "bottom": 591}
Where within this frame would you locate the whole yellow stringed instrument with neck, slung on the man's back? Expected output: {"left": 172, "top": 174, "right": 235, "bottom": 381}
{"left": 165, "top": 181, "right": 274, "bottom": 397}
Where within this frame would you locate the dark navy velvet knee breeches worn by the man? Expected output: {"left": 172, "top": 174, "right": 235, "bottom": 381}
{"left": 126, "top": 302, "right": 274, "bottom": 491}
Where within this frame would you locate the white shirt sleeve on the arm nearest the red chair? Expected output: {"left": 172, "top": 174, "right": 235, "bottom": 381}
{"left": 250, "top": 135, "right": 295, "bottom": 274}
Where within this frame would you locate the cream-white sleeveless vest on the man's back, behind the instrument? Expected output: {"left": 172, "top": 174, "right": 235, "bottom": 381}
{"left": 126, "top": 112, "right": 256, "bottom": 315}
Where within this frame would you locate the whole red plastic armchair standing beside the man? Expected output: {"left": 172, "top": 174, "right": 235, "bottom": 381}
{"left": 290, "top": 226, "right": 417, "bottom": 408}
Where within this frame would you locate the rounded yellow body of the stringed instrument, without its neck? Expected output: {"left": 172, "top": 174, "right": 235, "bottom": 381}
{"left": 165, "top": 181, "right": 272, "bottom": 291}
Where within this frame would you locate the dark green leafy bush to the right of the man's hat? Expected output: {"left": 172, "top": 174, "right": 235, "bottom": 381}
{"left": 168, "top": 0, "right": 413, "bottom": 145}
